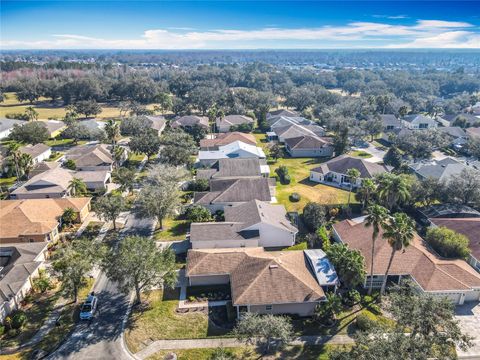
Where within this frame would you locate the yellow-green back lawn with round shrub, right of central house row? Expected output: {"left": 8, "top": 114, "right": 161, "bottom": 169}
{"left": 270, "top": 158, "right": 355, "bottom": 212}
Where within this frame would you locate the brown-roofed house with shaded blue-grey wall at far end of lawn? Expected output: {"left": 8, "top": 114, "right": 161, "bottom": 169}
{"left": 285, "top": 135, "right": 334, "bottom": 157}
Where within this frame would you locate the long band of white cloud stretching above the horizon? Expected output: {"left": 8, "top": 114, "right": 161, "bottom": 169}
{"left": 2, "top": 20, "right": 480, "bottom": 49}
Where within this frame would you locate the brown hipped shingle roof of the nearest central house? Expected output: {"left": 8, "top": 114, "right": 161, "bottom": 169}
{"left": 186, "top": 248, "right": 325, "bottom": 305}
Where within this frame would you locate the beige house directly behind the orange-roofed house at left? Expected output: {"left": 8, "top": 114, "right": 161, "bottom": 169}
{"left": 10, "top": 167, "right": 110, "bottom": 199}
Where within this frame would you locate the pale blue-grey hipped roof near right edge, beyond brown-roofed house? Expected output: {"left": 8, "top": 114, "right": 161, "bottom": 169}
{"left": 409, "top": 157, "right": 472, "bottom": 180}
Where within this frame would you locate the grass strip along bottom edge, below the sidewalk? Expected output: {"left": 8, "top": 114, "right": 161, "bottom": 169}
{"left": 148, "top": 345, "right": 348, "bottom": 360}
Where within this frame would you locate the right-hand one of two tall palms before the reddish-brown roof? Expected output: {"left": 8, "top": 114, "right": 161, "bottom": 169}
{"left": 380, "top": 213, "right": 415, "bottom": 295}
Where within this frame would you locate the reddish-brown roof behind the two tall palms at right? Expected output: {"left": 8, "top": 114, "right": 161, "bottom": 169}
{"left": 333, "top": 217, "right": 480, "bottom": 292}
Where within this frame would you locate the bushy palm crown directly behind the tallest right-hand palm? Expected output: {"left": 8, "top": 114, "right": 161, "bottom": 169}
{"left": 377, "top": 173, "right": 410, "bottom": 211}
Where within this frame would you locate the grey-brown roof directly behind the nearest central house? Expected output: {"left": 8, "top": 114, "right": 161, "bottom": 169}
{"left": 190, "top": 200, "right": 298, "bottom": 241}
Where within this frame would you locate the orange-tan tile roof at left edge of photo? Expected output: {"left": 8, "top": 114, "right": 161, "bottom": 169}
{"left": 0, "top": 198, "right": 90, "bottom": 239}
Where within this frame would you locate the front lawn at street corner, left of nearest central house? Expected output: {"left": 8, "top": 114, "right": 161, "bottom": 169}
{"left": 125, "top": 289, "right": 232, "bottom": 353}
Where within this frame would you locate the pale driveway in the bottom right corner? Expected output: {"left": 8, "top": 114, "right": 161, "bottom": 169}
{"left": 455, "top": 302, "right": 480, "bottom": 360}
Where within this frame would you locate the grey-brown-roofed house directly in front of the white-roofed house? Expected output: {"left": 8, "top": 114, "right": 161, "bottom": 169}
{"left": 197, "top": 158, "right": 270, "bottom": 180}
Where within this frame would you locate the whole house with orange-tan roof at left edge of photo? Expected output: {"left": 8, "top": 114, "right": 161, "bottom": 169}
{"left": 0, "top": 198, "right": 90, "bottom": 244}
